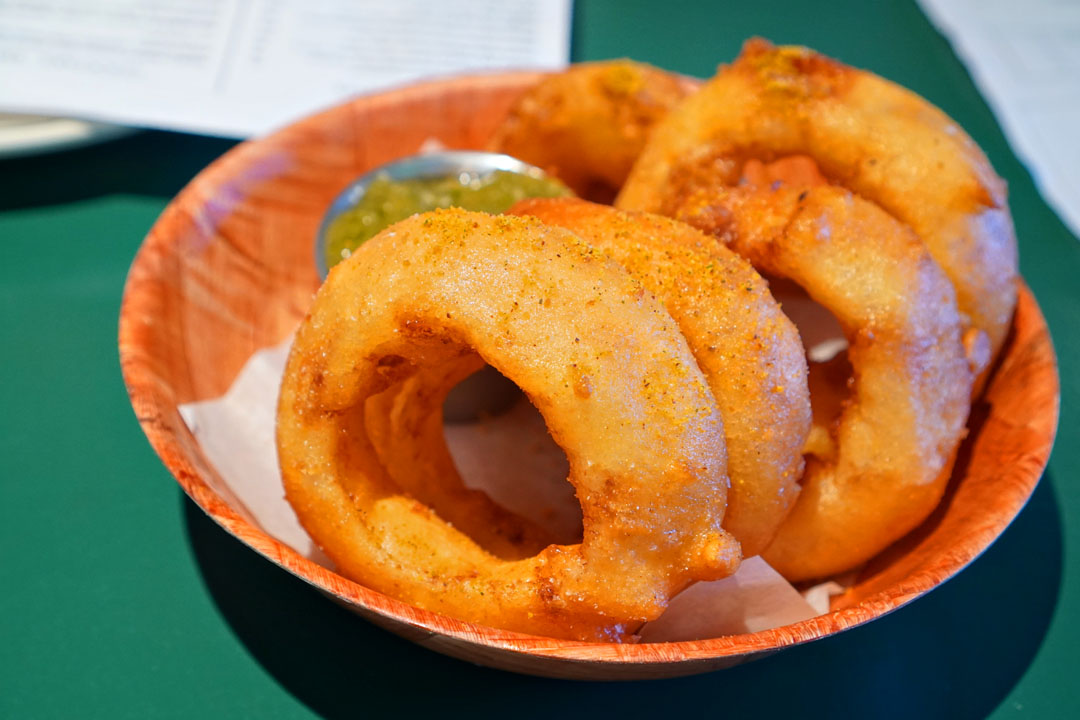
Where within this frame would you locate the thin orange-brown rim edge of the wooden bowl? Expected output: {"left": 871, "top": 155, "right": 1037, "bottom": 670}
{"left": 119, "top": 71, "right": 1059, "bottom": 665}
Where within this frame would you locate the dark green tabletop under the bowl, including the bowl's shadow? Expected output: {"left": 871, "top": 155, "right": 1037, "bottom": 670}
{"left": 0, "top": 0, "right": 1080, "bottom": 718}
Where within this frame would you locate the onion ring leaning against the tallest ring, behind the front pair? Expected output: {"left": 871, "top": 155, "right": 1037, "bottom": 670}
{"left": 677, "top": 187, "right": 973, "bottom": 581}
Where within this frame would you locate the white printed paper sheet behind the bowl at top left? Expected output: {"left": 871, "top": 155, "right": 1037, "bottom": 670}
{"left": 0, "top": 0, "right": 570, "bottom": 137}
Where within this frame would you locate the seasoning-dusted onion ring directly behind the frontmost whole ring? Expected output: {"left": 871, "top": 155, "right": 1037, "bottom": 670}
{"left": 509, "top": 199, "right": 810, "bottom": 557}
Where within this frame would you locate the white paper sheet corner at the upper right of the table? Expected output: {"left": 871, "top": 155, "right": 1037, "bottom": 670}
{"left": 919, "top": 0, "right": 1080, "bottom": 237}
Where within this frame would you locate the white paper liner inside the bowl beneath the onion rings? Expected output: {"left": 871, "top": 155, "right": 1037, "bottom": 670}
{"left": 179, "top": 340, "right": 825, "bottom": 642}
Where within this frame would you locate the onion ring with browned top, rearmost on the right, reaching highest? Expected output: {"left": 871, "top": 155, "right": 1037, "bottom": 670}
{"left": 617, "top": 40, "right": 1017, "bottom": 371}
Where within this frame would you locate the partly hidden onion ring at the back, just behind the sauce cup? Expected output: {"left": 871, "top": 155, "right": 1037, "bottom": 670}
{"left": 490, "top": 60, "right": 694, "bottom": 202}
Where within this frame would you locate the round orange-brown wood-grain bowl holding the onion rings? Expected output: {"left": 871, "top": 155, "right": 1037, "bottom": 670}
{"left": 120, "top": 72, "right": 1058, "bottom": 679}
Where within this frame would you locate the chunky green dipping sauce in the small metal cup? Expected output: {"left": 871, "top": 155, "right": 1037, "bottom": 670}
{"left": 325, "top": 171, "right": 573, "bottom": 269}
